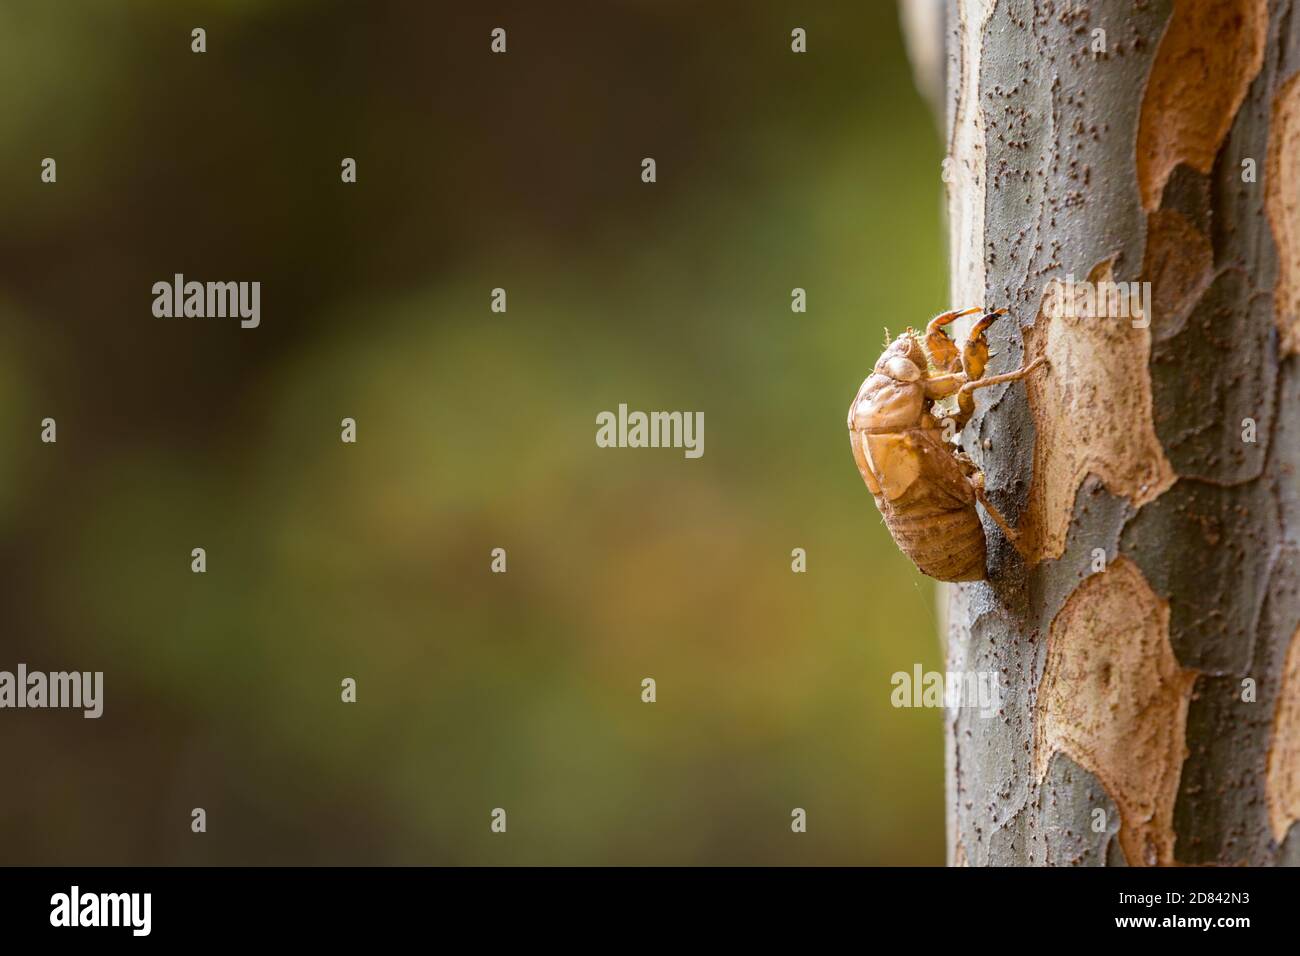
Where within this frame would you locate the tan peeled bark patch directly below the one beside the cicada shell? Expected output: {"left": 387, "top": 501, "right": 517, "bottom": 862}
{"left": 1034, "top": 558, "right": 1196, "bottom": 865}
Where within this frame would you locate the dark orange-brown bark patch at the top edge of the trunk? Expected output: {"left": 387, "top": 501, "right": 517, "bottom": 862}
{"left": 1138, "top": 0, "right": 1269, "bottom": 212}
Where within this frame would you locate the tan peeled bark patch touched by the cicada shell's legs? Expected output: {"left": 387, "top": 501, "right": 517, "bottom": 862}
{"left": 1021, "top": 260, "right": 1175, "bottom": 563}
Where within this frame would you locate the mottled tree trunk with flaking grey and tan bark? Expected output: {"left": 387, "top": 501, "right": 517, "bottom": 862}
{"left": 945, "top": 0, "right": 1300, "bottom": 866}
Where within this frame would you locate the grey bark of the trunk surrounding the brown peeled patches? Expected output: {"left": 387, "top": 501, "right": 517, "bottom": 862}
{"left": 945, "top": 0, "right": 1300, "bottom": 865}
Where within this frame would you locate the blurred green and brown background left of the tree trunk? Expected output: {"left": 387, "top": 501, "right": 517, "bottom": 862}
{"left": 0, "top": 0, "right": 948, "bottom": 864}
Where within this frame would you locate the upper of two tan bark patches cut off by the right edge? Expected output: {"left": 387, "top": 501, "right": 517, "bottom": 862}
{"left": 1264, "top": 73, "right": 1300, "bottom": 355}
